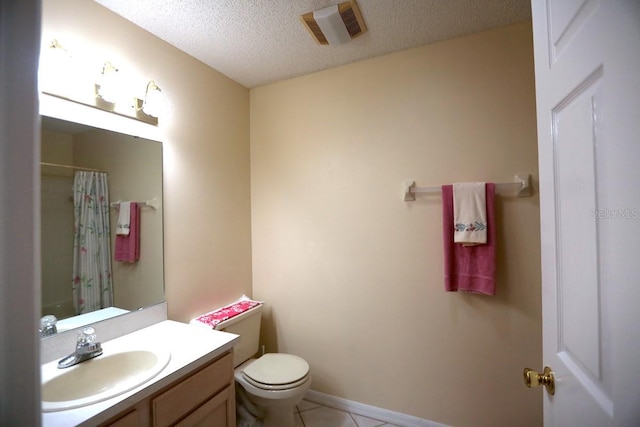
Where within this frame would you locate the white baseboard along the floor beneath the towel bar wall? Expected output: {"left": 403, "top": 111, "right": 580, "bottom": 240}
{"left": 304, "top": 390, "right": 448, "bottom": 427}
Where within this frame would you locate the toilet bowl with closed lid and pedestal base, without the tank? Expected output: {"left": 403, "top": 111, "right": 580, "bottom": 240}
{"left": 234, "top": 353, "right": 311, "bottom": 427}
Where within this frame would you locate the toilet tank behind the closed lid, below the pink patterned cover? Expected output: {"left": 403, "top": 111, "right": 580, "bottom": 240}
{"left": 216, "top": 304, "right": 262, "bottom": 367}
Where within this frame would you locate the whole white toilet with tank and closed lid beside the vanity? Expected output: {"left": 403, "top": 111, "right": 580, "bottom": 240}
{"left": 215, "top": 304, "right": 311, "bottom": 427}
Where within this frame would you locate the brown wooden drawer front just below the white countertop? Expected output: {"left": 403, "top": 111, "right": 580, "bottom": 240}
{"left": 151, "top": 353, "right": 233, "bottom": 427}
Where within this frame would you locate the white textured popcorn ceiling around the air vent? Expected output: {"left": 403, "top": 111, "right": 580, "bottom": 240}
{"left": 95, "top": 0, "right": 531, "bottom": 88}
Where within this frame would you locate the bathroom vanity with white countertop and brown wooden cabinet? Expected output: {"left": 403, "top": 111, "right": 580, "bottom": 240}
{"left": 42, "top": 320, "right": 238, "bottom": 427}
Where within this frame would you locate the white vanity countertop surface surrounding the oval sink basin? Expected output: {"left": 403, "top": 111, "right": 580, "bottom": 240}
{"left": 42, "top": 320, "right": 239, "bottom": 427}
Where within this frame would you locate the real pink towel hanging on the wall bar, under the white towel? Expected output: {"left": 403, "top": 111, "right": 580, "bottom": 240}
{"left": 442, "top": 183, "right": 496, "bottom": 295}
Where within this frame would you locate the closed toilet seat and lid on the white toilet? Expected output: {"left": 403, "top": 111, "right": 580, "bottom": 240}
{"left": 242, "top": 353, "right": 309, "bottom": 390}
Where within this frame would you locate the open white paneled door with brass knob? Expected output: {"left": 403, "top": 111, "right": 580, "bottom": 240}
{"left": 532, "top": 0, "right": 640, "bottom": 427}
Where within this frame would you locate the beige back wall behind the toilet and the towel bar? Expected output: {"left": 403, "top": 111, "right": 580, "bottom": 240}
{"left": 251, "top": 24, "right": 542, "bottom": 427}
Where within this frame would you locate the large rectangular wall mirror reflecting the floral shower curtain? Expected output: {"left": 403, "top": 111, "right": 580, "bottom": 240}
{"left": 41, "top": 110, "right": 164, "bottom": 338}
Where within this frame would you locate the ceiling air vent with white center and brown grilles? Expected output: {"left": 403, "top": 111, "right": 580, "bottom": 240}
{"left": 301, "top": 0, "right": 367, "bottom": 44}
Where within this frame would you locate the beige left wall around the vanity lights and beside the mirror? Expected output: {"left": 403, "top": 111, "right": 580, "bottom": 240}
{"left": 42, "top": 0, "right": 251, "bottom": 321}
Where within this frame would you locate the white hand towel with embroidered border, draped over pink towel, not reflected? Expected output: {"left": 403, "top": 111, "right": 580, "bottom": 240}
{"left": 453, "top": 182, "right": 487, "bottom": 246}
